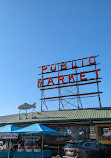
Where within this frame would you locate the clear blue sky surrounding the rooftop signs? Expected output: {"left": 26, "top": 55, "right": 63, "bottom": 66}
{"left": 0, "top": 0, "right": 111, "bottom": 115}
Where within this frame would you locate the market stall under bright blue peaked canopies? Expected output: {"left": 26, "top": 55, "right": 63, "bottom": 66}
{"left": 0, "top": 123, "right": 58, "bottom": 158}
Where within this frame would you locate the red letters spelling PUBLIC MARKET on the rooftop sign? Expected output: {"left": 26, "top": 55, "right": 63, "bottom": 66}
{"left": 37, "top": 56, "right": 101, "bottom": 87}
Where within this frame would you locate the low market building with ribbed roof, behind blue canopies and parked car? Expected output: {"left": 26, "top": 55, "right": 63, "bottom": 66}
{"left": 0, "top": 108, "right": 111, "bottom": 145}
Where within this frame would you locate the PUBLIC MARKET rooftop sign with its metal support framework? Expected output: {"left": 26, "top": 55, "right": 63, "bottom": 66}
{"left": 37, "top": 55, "right": 102, "bottom": 111}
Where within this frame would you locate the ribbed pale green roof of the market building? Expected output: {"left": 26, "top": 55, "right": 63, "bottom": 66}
{"left": 0, "top": 108, "right": 111, "bottom": 124}
